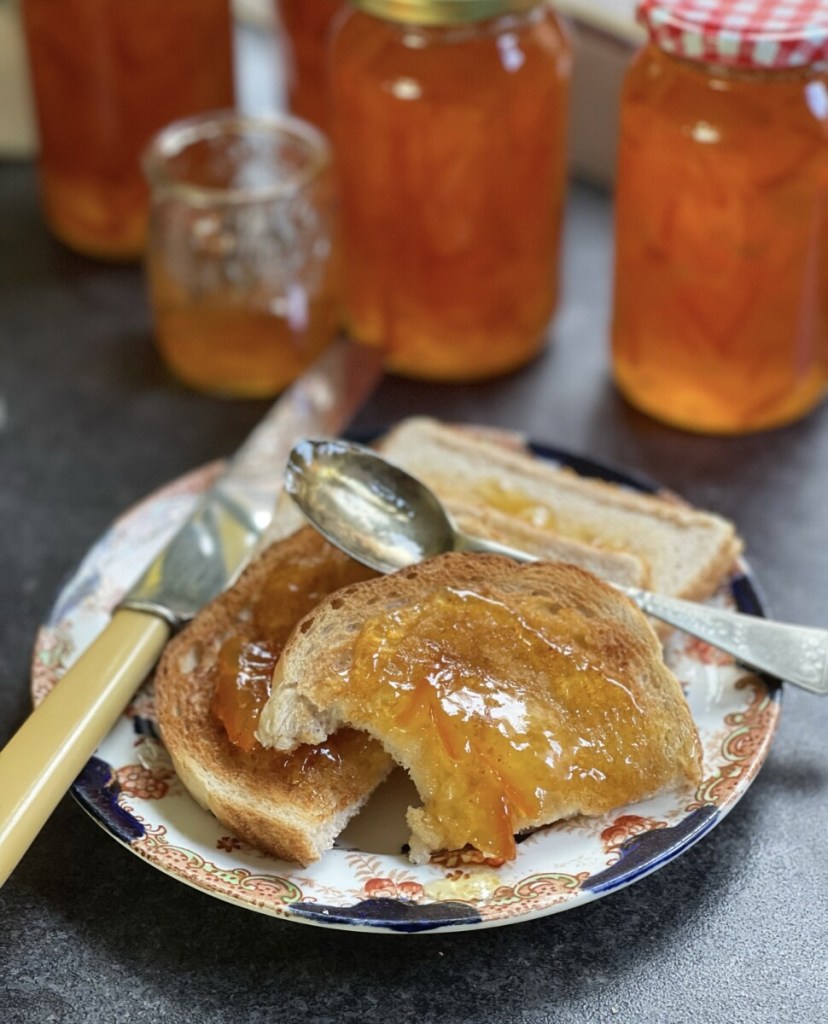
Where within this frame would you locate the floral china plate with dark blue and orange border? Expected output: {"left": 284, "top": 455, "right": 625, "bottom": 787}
{"left": 33, "top": 445, "right": 781, "bottom": 932}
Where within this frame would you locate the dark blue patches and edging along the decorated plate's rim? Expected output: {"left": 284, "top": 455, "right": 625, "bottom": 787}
{"left": 34, "top": 438, "right": 782, "bottom": 933}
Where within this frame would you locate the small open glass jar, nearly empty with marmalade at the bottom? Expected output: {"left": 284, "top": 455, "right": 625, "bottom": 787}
{"left": 143, "top": 111, "right": 339, "bottom": 398}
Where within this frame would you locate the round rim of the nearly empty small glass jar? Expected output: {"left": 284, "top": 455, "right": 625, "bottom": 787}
{"left": 141, "top": 110, "right": 331, "bottom": 206}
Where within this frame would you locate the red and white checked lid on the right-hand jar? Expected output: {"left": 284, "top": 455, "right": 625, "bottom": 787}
{"left": 638, "top": 0, "right": 828, "bottom": 69}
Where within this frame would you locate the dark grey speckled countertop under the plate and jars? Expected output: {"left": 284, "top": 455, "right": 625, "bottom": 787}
{"left": 0, "top": 155, "right": 828, "bottom": 1024}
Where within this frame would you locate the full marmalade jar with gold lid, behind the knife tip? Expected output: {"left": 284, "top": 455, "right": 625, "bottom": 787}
{"left": 333, "top": 0, "right": 570, "bottom": 380}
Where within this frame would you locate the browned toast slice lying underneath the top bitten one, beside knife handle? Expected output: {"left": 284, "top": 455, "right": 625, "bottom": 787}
{"left": 155, "top": 527, "right": 392, "bottom": 864}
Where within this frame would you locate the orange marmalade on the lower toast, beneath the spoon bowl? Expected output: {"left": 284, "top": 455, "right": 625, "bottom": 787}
{"left": 213, "top": 527, "right": 377, "bottom": 751}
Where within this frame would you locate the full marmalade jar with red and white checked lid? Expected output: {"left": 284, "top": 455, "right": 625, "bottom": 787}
{"left": 613, "top": 0, "right": 828, "bottom": 433}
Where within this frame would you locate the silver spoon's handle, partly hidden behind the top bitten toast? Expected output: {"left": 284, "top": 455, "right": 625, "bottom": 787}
{"left": 456, "top": 532, "right": 828, "bottom": 694}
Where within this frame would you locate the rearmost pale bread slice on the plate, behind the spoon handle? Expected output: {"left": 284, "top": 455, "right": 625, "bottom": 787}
{"left": 381, "top": 417, "right": 741, "bottom": 600}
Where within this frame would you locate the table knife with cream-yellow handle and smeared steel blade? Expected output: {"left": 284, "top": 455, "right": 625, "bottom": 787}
{"left": 0, "top": 339, "right": 383, "bottom": 886}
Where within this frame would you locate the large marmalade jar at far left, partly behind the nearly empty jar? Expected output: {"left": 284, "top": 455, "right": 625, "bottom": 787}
{"left": 23, "top": 0, "right": 234, "bottom": 260}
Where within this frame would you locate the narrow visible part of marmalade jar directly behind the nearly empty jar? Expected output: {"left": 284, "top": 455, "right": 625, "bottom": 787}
{"left": 276, "top": 0, "right": 345, "bottom": 132}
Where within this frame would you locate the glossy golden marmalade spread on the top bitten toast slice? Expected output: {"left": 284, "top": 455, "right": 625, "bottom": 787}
{"left": 340, "top": 588, "right": 676, "bottom": 858}
